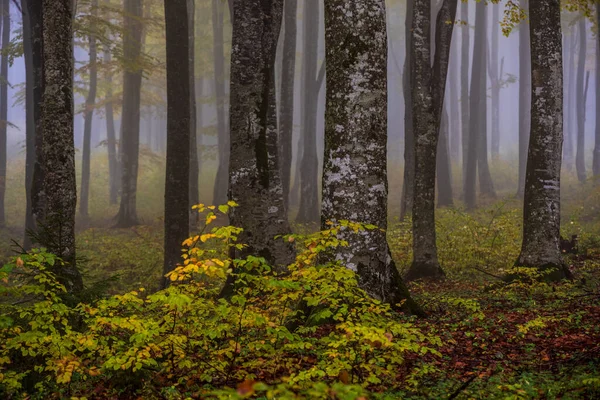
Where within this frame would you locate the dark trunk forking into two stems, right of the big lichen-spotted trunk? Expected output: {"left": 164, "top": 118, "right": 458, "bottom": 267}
{"left": 405, "top": 0, "right": 457, "bottom": 279}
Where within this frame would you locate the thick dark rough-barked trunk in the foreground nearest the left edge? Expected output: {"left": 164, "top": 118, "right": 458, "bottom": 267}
{"left": 38, "top": 0, "right": 83, "bottom": 292}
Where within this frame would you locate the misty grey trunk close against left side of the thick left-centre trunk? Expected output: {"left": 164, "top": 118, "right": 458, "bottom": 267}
{"left": 212, "top": 0, "right": 231, "bottom": 204}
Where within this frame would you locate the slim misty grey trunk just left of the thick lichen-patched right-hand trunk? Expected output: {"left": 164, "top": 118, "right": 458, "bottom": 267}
{"left": 517, "top": 0, "right": 531, "bottom": 199}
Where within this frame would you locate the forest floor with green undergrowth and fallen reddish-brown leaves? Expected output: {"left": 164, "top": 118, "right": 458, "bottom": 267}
{"left": 0, "top": 155, "right": 600, "bottom": 399}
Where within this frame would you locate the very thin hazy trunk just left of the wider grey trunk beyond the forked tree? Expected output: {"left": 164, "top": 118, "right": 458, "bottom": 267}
{"left": 460, "top": 1, "right": 471, "bottom": 189}
